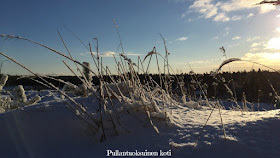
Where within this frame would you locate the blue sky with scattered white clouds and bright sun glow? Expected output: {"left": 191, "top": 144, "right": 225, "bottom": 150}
{"left": 0, "top": 0, "right": 280, "bottom": 74}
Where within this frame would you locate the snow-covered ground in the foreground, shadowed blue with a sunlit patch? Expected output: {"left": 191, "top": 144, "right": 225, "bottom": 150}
{"left": 0, "top": 91, "right": 280, "bottom": 158}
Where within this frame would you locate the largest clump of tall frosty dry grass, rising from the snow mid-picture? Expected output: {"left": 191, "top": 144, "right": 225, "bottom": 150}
{"left": 0, "top": 32, "right": 179, "bottom": 141}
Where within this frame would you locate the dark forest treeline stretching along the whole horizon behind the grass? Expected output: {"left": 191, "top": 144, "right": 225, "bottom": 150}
{"left": 3, "top": 70, "right": 280, "bottom": 103}
